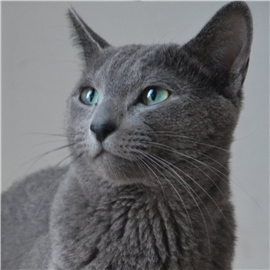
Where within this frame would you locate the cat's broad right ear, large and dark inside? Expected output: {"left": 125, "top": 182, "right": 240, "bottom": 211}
{"left": 185, "top": 1, "right": 252, "bottom": 84}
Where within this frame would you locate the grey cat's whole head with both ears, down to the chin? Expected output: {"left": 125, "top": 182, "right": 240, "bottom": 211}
{"left": 67, "top": 1, "right": 252, "bottom": 185}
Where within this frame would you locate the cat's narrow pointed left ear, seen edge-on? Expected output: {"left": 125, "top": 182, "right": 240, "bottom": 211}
{"left": 68, "top": 6, "right": 110, "bottom": 63}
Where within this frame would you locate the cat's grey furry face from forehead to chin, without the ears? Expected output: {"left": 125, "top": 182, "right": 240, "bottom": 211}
{"left": 66, "top": 45, "right": 238, "bottom": 186}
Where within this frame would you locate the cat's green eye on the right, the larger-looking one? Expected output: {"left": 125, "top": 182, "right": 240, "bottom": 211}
{"left": 142, "top": 87, "right": 170, "bottom": 105}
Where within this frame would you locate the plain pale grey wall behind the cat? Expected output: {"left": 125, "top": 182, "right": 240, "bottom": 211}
{"left": 1, "top": 1, "right": 269, "bottom": 269}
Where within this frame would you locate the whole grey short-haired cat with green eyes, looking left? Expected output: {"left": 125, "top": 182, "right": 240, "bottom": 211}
{"left": 1, "top": 1, "right": 252, "bottom": 270}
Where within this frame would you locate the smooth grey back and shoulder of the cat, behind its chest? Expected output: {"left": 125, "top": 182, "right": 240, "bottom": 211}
{"left": 0, "top": 167, "right": 68, "bottom": 269}
